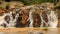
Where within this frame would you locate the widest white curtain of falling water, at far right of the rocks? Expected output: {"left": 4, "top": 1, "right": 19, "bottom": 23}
{"left": 48, "top": 10, "right": 58, "bottom": 28}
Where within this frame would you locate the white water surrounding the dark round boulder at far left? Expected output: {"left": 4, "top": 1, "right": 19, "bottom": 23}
{"left": 0, "top": 12, "right": 19, "bottom": 28}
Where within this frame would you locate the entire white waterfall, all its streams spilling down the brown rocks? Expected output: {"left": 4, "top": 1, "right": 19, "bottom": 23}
{"left": 0, "top": 7, "right": 58, "bottom": 28}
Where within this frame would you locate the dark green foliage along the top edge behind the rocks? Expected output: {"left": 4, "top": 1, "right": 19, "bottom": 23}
{"left": 20, "top": 0, "right": 57, "bottom": 5}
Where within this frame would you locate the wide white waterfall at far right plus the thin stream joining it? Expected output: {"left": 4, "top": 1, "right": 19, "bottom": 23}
{"left": 40, "top": 10, "right": 58, "bottom": 28}
